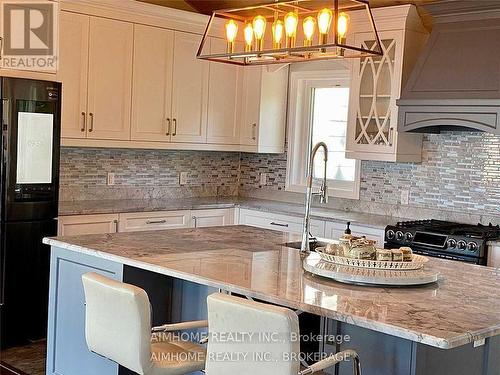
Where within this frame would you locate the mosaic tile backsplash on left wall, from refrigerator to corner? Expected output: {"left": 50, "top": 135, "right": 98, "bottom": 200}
{"left": 59, "top": 148, "right": 240, "bottom": 200}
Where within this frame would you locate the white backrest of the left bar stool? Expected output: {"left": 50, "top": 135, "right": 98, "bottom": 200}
{"left": 82, "top": 272, "right": 152, "bottom": 375}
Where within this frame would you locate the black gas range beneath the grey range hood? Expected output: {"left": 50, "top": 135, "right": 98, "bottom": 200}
{"left": 385, "top": 220, "right": 500, "bottom": 265}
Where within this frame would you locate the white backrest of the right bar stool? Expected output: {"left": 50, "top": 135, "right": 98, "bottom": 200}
{"left": 206, "top": 293, "right": 300, "bottom": 375}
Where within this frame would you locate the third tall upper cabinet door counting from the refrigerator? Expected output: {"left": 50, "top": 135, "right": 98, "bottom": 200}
{"left": 131, "top": 25, "right": 174, "bottom": 142}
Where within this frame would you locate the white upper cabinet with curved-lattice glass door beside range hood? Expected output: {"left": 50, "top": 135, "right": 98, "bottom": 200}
{"left": 346, "top": 6, "right": 427, "bottom": 162}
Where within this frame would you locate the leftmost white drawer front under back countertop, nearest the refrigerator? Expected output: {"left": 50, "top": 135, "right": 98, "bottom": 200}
{"left": 57, "top": 214, "right": 118, "bottom": 236}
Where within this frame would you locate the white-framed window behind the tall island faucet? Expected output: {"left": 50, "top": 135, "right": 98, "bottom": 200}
{"left": 287, "top": 68, "right": 360, "bottom": 199}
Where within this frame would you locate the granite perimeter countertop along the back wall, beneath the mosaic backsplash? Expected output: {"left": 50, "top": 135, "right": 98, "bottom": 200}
{"left": 59, "top": 197, "right": 405, "bottom": 229}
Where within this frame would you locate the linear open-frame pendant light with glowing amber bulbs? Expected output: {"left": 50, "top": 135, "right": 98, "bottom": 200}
{"left": 196, "top": 0, "right": 383, "bottom": 65}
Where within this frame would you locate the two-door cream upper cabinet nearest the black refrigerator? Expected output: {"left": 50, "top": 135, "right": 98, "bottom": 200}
{"left": 58, "top": 11, "right": 133, "bottom": 141}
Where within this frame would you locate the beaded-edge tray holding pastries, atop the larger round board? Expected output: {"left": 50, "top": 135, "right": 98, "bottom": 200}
{"left": 316, "top": 247, "right": 429, "bottom": 271}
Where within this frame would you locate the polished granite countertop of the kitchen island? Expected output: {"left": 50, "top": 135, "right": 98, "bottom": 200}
{"left": 44, "top": 226, "right": 500, "bottom": 349}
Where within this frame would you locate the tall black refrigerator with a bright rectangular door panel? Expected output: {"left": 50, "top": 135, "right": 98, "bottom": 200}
{"left": 0, "top": 77, "right": 61, "bottom": 349}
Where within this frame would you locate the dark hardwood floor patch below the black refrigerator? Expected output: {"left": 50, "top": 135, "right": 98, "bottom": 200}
{"left": 0, "top": 341, "right": 47, "bottom": 375}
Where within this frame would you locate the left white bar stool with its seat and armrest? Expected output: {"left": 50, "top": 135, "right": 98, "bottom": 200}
{"left": 82, "top": 273, "right": 207, "bottom": 375}
